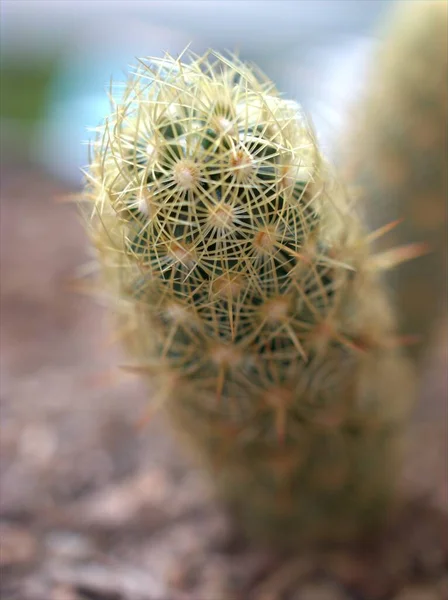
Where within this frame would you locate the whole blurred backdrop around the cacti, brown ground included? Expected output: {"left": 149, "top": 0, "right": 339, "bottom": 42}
{"left": 0, "top": 0, "right": 448, "bottom": 600}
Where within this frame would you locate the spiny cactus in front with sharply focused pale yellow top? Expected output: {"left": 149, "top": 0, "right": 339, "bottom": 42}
{"left": 85, "top": 52, "right": 413, "bottom": 546}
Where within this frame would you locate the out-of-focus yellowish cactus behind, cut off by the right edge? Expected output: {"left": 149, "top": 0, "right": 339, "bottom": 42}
{"left": 347, "top": 0, "right": 448, "bottom": 360}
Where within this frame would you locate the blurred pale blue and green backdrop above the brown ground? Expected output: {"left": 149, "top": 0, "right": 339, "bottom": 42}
{"left": 0, "top": 0, "right": 396, "bottom": 185}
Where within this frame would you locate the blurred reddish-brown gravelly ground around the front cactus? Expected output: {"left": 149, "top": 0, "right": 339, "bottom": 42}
{"left": 0, "top": 165, "right": 448, "bottom": 600}
